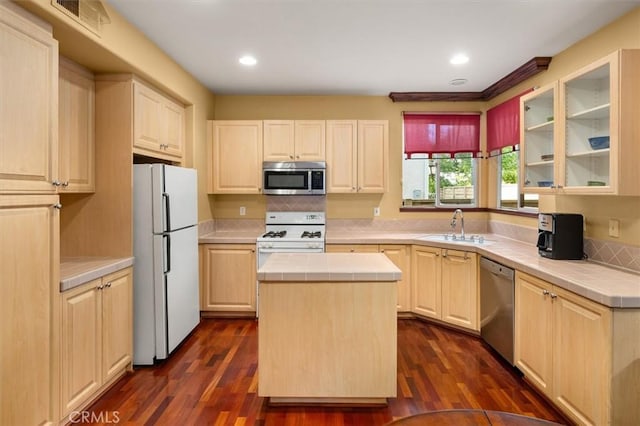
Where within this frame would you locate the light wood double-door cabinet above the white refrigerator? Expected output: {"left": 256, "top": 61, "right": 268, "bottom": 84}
{"left": 133, "top": 80, "right": 185, "bottom": 162}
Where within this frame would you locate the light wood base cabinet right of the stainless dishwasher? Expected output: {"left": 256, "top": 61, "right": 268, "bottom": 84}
{"left": 515, "top": 271, "right": 640, "bottom": 425}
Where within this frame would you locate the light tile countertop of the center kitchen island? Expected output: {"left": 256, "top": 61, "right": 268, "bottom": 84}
{"left": 258, "top": 253, "right": 402, "bottom": 282}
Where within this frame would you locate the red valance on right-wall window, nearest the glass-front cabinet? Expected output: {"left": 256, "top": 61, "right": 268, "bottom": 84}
{"left": 487, "top": 90, "right": 531, "bottom": 155}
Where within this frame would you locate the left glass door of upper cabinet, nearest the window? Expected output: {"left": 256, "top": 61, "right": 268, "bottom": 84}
{"left": 520, "top": 83, "right": 558, "bottom": 192}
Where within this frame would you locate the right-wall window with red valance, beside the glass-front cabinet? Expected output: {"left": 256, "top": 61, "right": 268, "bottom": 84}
{"left": 487, "top": 90, "right": 538, "bottom": 210}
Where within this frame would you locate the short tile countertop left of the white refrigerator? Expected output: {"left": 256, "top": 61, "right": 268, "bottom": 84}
{"left": 60, "top": 257, "right": 133, "bottom": 292}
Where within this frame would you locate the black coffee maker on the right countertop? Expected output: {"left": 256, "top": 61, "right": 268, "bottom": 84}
{"left": 538, "top": 213, "right": 584, "bottom": 260}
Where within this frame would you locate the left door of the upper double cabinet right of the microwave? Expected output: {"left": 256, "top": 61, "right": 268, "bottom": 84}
{"left": 326, "top": 120, "right": 358, "bottom": 193}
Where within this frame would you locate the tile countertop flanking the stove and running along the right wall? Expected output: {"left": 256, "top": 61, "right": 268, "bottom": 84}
{"left": 200, "top": 231, "right": 640, "bottom": 308}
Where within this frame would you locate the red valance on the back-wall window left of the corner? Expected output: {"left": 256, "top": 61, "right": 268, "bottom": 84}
{"left": 404, "top": 113, "right": 480, "bottom": 158}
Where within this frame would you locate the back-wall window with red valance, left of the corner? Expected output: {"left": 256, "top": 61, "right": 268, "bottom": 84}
{"left": 402, "top": 113, "right": 480, "bottom": 207}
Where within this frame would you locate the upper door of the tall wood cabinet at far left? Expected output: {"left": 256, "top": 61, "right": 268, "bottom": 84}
{"left": 0, "top": 2, "right": 58, "bottom": 193}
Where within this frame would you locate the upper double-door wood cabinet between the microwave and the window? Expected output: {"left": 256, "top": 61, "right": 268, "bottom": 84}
{"left": 327, "top": 120, "right": 389, "bottom": 193}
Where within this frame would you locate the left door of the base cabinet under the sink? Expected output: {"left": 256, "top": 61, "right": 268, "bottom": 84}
{"left": 411, "top": 246, "right": 442, "bottom": 319}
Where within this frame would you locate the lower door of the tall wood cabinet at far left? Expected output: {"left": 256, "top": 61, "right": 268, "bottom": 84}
{"left": 0, "top": 195, "right": 60, "bottom": 425}
